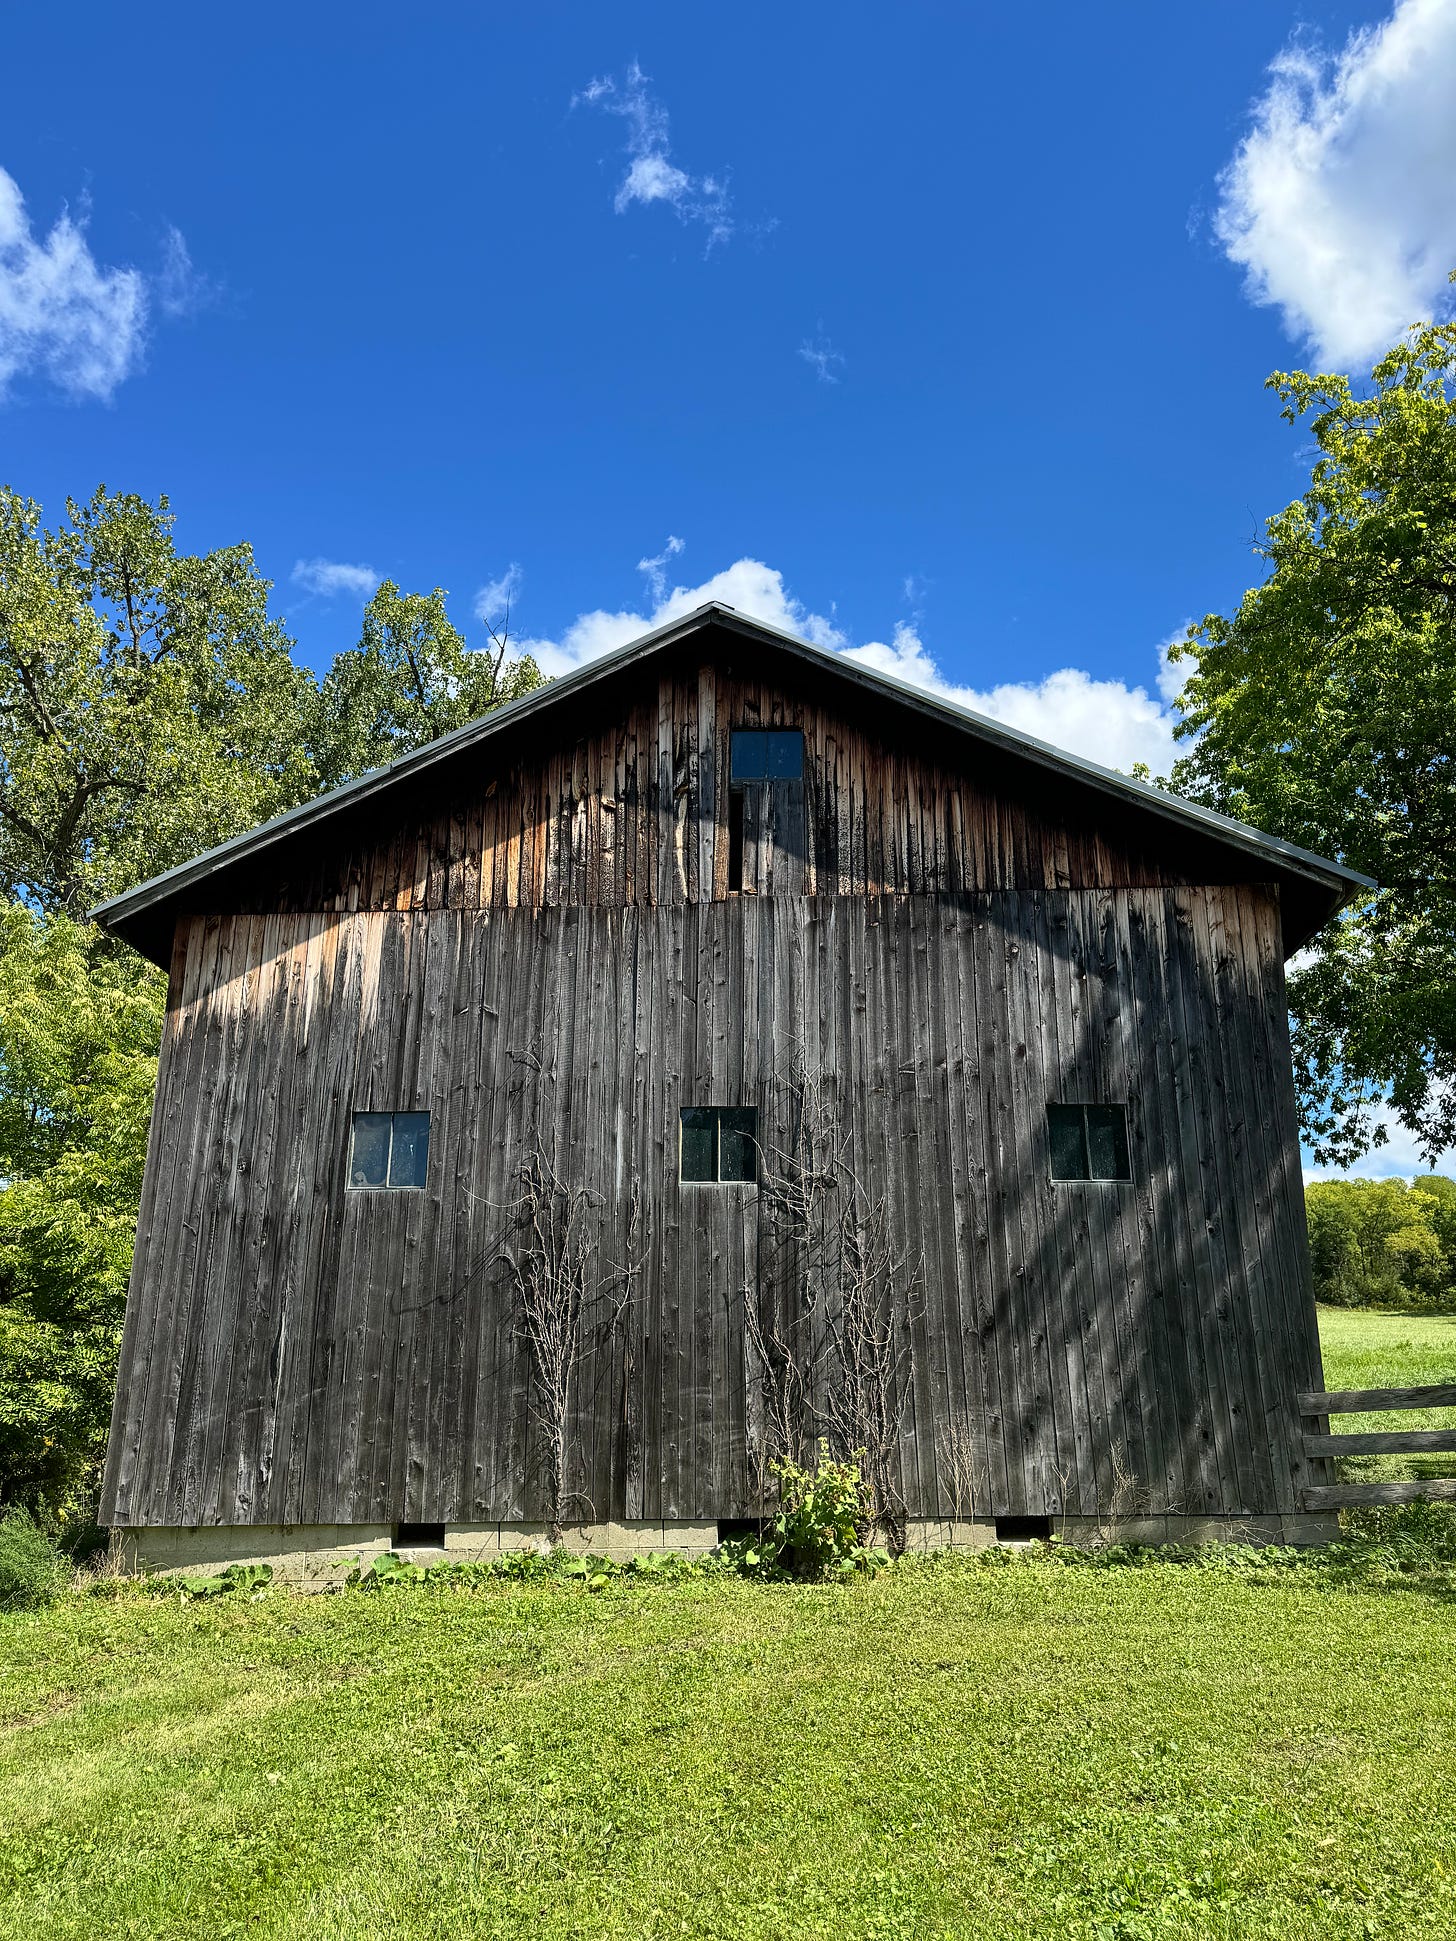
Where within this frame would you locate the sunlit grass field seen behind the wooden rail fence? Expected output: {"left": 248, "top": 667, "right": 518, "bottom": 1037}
{"left": 1320, "top": 1308, "right": 1456, "bottom": 1481}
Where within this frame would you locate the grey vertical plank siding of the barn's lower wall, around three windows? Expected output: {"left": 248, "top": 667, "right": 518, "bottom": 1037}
{"left": 103, "top": 885, "right": 1320, "bottom": 1526}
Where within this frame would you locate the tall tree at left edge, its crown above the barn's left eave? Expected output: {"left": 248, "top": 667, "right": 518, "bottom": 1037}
{"left": 0, "top": 487, "right": 316, "bottom": 916}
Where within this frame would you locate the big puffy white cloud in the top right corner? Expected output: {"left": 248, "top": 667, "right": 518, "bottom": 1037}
{"left": 1215, "top": 0, "right": 1456, "bottom": 369}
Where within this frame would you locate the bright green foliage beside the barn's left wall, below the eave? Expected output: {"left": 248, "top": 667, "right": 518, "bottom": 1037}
{"left": 0, "top": 903, "right": 167, "bottom": 1510}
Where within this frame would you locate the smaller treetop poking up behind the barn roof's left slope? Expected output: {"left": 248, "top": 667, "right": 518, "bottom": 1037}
{"left": 313, "top": 580, "right": 542, "bottom": 788}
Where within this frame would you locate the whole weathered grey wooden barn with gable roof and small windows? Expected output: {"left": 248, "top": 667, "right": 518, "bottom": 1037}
{"left": 99, "top": 606, "right": 1361, "bottom": 1572}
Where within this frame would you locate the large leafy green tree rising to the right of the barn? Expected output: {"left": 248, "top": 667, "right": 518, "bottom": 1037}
{"left": 1173, "top": 289, "right": 1456, "bottom": 1165}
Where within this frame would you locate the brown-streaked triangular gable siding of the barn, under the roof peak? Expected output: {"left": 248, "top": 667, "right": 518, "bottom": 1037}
{"left": 229, "top": 660, "right": 1248, "bottom": 910}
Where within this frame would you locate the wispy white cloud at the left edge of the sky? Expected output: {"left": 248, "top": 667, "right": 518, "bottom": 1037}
{"left": 0, "top": 169, "right": 148, "bottom": 400}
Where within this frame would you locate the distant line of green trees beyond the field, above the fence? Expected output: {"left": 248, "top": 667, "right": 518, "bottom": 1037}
{"left": 1305, "top": 1172, "right": 1456, "bottom": 1314}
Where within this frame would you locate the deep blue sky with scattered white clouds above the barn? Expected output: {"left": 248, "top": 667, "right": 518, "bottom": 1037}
{"left": 0, "top": 0, "right": 1456, "bottom": 1164}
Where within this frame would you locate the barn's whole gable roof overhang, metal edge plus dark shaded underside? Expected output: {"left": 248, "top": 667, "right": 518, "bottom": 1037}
{"left": 91, "top": 600, "right": 1374, "bottom": 965}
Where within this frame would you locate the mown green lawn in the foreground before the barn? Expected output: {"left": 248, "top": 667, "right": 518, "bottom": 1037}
{"left": 0, "top": 1561, "right": 1456, "bottom": 1941}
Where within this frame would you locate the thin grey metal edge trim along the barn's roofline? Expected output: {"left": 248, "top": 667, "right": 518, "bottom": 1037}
{"left": 91, "top": 600, "right": 1378, "bottom": 928}
